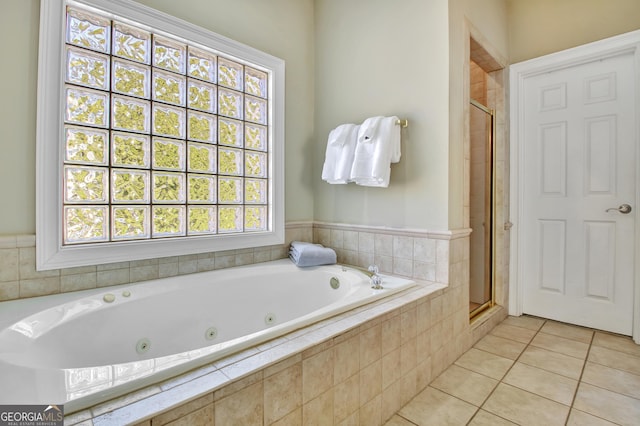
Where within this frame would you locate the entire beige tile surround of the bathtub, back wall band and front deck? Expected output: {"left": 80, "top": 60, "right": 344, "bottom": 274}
{"left": 0, "top": 222, "right": 506, "bottom": 425}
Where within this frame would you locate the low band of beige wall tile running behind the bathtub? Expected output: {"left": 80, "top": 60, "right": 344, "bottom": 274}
{"left": 0, "top": 222, "right": 460, "bottom": 302}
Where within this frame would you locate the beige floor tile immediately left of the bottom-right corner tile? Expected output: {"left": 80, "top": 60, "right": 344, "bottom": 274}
{"left": 502, "top": 362, "right": 578, "bottom": 405}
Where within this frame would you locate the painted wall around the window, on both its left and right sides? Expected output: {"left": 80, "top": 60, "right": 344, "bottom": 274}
{"left": 0, "top": 0, "right": 314, "bottom": 236}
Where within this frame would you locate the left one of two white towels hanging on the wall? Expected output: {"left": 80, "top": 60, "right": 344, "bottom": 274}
{"left": 322, "top": 124, "right": 360, "bottom": 184}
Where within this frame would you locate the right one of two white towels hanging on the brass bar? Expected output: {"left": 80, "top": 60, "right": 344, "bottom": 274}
{"left": 351, "top": 116, "right": 401, "bottom": 188}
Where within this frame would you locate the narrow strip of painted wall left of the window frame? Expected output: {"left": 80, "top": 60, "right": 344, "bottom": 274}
{"left": 0, "top": 0, "right": 40, "bottom": 235}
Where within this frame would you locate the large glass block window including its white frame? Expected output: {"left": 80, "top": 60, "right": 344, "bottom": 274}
{"left": 36, "top": 0, "right": 285, "bottom": 270}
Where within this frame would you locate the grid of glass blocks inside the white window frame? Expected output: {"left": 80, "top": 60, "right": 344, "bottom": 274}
{"left": 62, "top": 2, "right": 272, "bottom": 245}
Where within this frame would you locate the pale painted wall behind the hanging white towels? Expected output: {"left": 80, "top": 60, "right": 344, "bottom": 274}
{"left": 312, "top": 0, "right": 449, "bottom": 229}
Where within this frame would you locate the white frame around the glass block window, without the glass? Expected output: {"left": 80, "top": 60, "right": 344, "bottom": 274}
{"left": 36, "top": 0, "right": 285, "bottom": 270}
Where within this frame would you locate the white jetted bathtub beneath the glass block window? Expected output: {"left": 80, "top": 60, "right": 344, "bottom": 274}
{"left": 0, "top": 259, "right": 414, "bottom": 412}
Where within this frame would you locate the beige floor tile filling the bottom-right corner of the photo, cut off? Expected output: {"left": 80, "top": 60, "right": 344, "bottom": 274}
{"left": 574, "top": 383, "right": 640, "bottom": 425}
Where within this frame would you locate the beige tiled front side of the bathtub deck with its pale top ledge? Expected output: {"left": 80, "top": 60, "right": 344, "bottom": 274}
{"left": 65, "top": 282, "right": 506, "bottom": 426}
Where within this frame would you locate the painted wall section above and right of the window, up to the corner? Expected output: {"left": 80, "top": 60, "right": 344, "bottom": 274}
{"left": 136, "top": 0, "right": 314, "bottom": 221}
